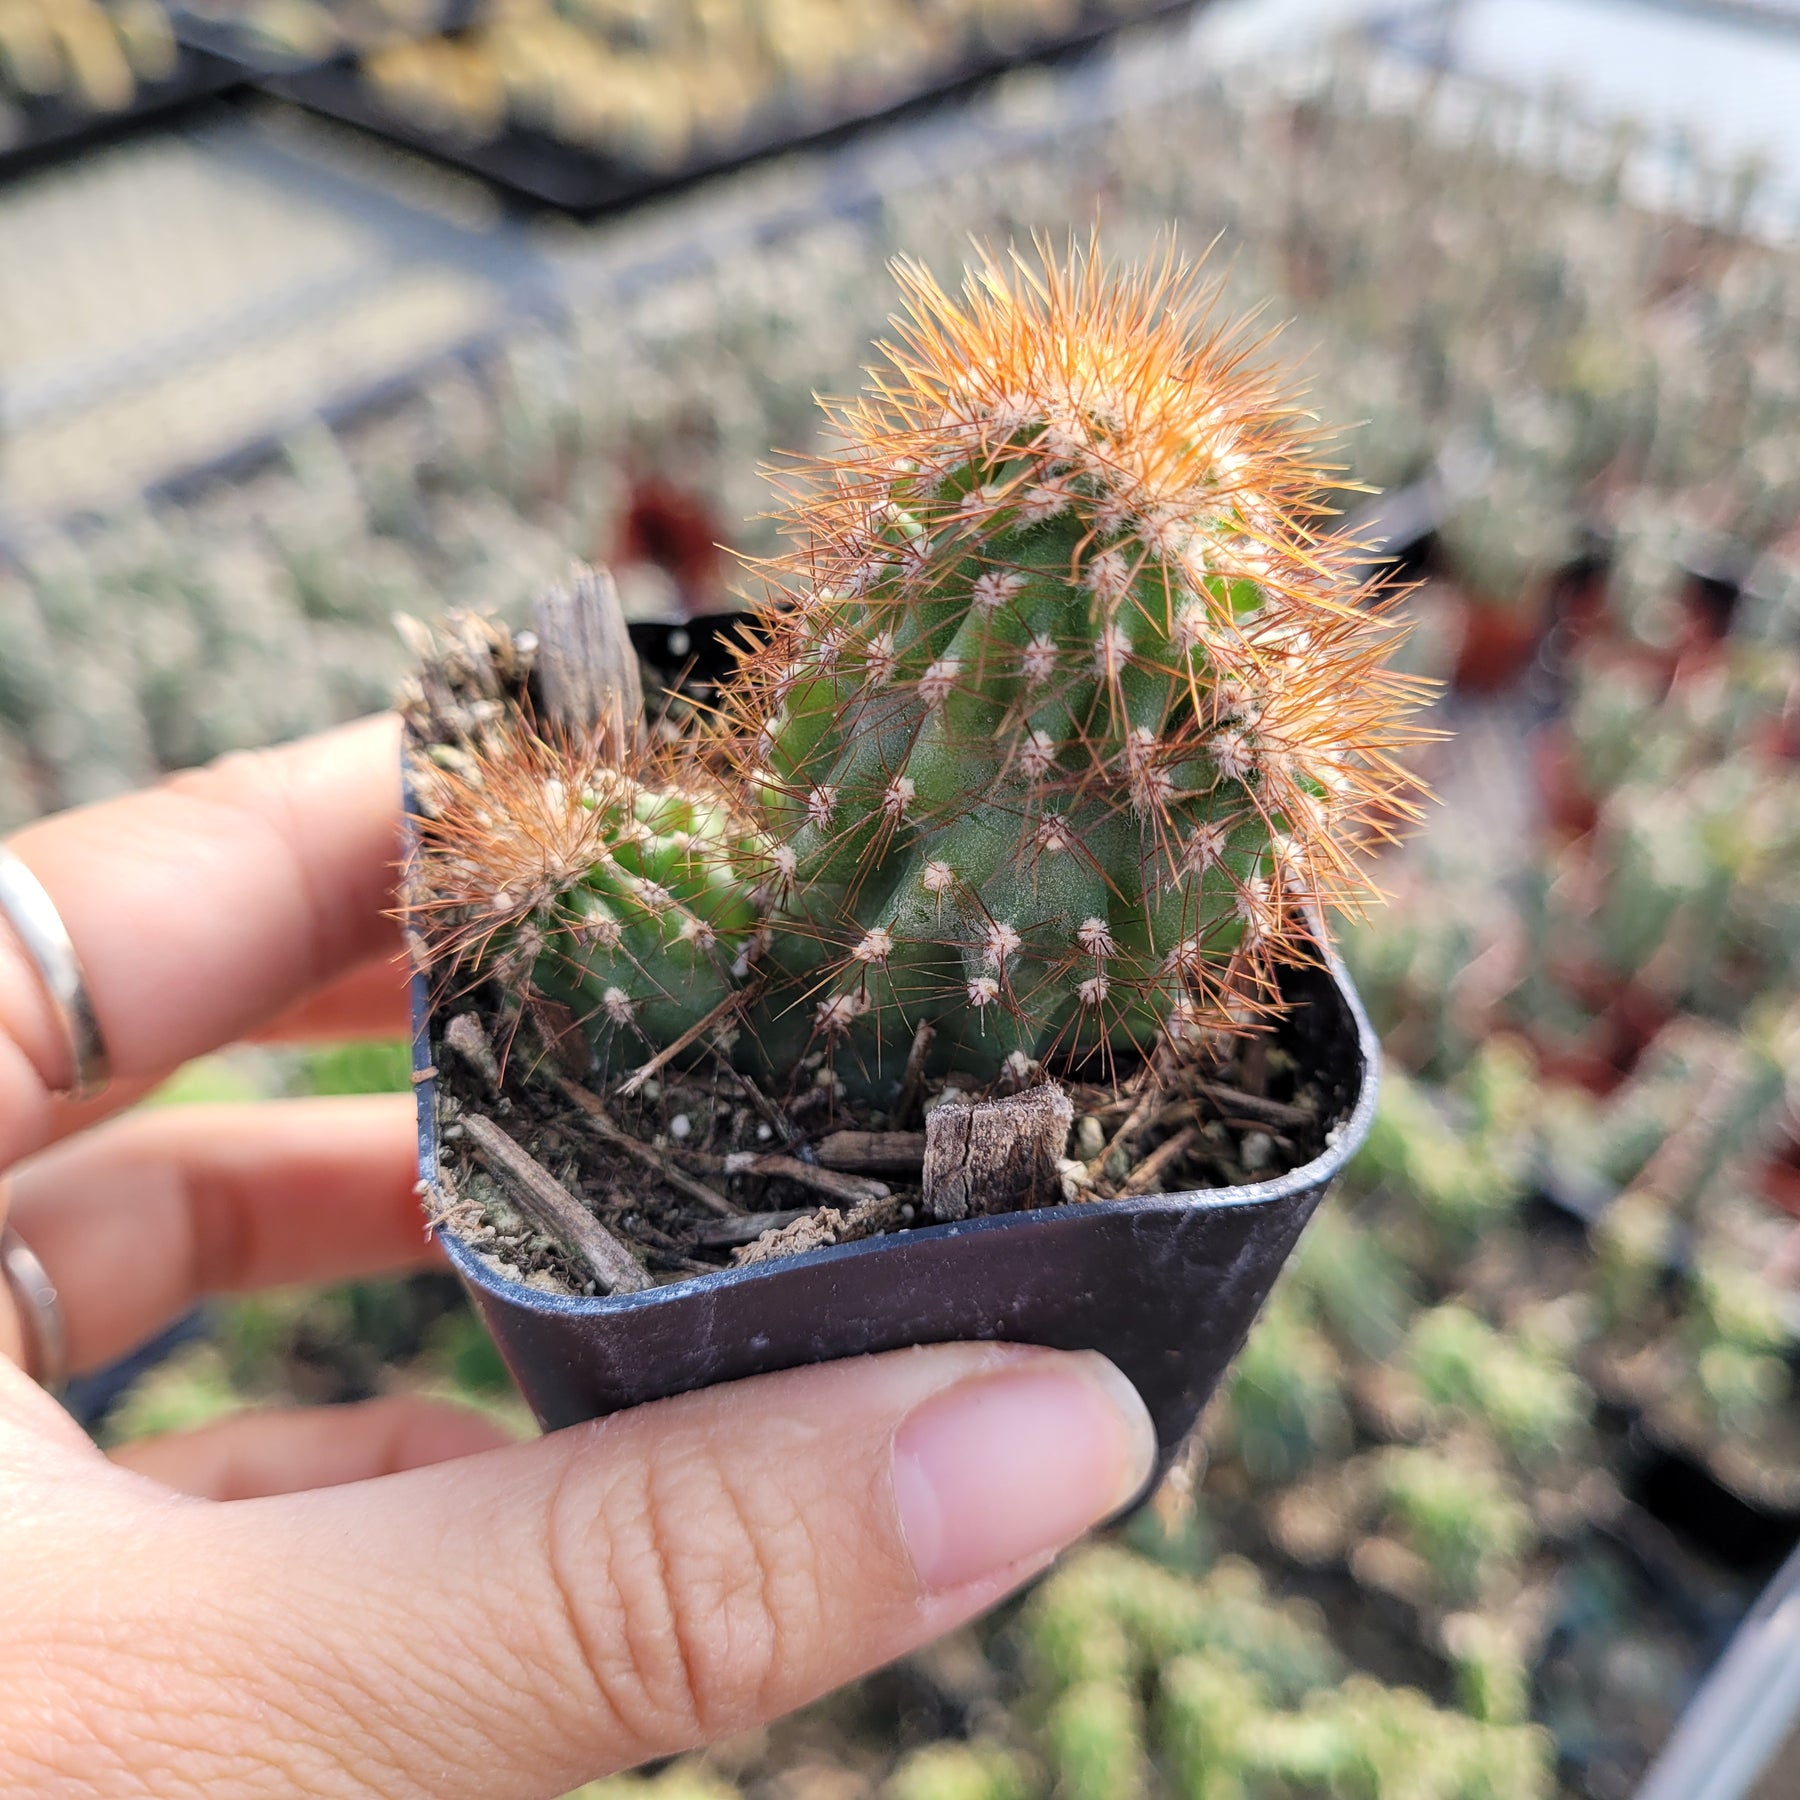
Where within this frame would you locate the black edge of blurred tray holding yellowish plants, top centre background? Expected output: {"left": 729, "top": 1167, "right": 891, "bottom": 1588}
{"left": 259, "top": 0, "right": 1204, "bottom": 212}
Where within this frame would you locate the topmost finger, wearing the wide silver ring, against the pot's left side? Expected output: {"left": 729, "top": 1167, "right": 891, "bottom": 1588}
{"left": 0, "top": 718, "right": 400, "bottom": 1166}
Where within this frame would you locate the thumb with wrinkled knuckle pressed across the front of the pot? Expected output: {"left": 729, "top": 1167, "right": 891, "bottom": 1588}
{"left": 59, "top": 1345, "right": 1156, "bottom": 1800}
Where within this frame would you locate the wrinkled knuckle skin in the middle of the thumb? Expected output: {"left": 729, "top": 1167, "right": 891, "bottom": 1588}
{"left": 549, "top": 1440, "right": 823, "bottom": 1755}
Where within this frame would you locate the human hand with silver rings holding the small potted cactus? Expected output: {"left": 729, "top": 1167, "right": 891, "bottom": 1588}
{"left": 0, "top": 720, "right": 1154, "bottom": 1800}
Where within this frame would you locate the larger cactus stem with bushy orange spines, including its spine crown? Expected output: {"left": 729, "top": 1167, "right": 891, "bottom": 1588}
{"left": 727, "top": 250, "right": 1415, "bottom": 1084}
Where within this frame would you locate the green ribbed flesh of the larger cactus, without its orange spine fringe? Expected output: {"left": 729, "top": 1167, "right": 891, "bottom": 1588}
{"left": 738, "top": 452, "right": 1289, "bottom": 1073}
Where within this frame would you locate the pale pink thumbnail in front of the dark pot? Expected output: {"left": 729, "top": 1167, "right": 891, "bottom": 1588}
{"left": 895, "top": 1350, "right": 1156, "bottom": 1591}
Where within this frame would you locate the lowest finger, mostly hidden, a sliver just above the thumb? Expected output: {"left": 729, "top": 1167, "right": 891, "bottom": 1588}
{"left": 112, "top": 1395, "right": 513, "bottom": 1499}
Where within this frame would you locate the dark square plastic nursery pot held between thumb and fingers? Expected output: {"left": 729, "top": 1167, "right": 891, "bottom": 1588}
{"left": 412, "top": 958, "right": 1377, "bottom": 1467}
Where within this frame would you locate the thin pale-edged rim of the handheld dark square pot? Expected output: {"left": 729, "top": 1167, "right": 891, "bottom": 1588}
{"left": 412, "top": 932, "right": 1381, "bottom": 1318}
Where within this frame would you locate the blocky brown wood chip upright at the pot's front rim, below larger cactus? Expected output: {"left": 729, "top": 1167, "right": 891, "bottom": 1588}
{"left": 925, "top": 1082, "right": 1075, "bottom": 1219}
